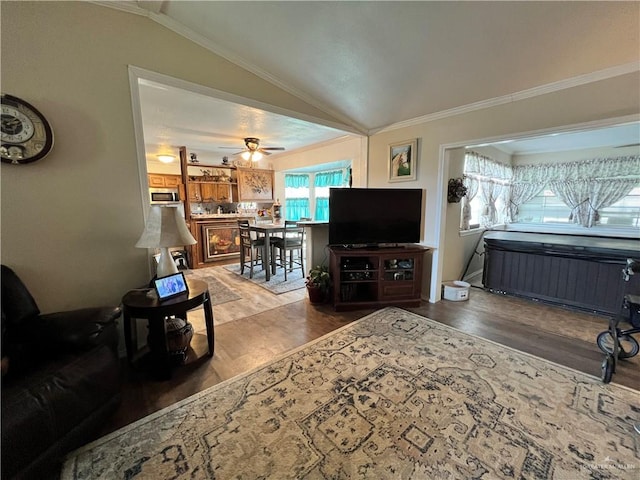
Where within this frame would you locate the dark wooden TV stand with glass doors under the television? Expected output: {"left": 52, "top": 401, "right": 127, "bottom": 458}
{"left": 329, "top": 245, "right": 428, "bottom": 310}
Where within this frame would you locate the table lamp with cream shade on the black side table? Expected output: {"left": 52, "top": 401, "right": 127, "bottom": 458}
{"left": 136, "top": 205, "right": 197, "bottom": 277}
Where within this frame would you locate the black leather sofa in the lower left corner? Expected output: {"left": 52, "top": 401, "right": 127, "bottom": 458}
{"left": 0, "top": 265, "right": 121, "bottom": 480}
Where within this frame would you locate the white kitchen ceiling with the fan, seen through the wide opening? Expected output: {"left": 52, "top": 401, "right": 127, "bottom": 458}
{"left": 138, "top": 79, "right": 350, "bottom": 167}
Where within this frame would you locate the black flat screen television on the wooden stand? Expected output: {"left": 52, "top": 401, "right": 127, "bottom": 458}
{"left": 329, "top": 188, "right": 422, "bottom": 247}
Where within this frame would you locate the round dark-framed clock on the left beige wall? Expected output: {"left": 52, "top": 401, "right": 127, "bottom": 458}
{"left": 0, "top": 93, "right": 53, "bottom": 165}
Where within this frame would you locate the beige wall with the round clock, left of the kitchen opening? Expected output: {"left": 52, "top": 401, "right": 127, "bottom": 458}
{"left": 0, "top": 2, "right": 344, "bottom": 311}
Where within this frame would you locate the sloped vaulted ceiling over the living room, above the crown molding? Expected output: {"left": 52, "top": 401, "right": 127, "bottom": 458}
{"left": 155, "top": 0, "right": 640, "bottom": 131}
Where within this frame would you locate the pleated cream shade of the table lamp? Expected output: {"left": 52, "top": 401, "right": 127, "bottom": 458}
{"left": 136, "top": 205, "right": 197, "bottom": 248}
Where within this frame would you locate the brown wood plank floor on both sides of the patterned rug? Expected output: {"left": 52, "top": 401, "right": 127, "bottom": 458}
{"left": 101, "top": 279, "right": 640, "bottom": 435}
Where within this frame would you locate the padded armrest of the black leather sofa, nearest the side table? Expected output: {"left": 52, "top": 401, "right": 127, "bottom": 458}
{"left": 39, "top": 307, "right": 121, "bottom": 350}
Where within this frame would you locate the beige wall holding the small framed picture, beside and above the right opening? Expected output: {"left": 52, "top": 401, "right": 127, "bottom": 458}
{"left": 369, "top": 72, "right": 640, "bottom": 300}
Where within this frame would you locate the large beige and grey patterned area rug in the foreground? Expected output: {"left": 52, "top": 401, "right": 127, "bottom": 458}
{"left": 61, "top": 308, "right": 640, "bottom": 480}
